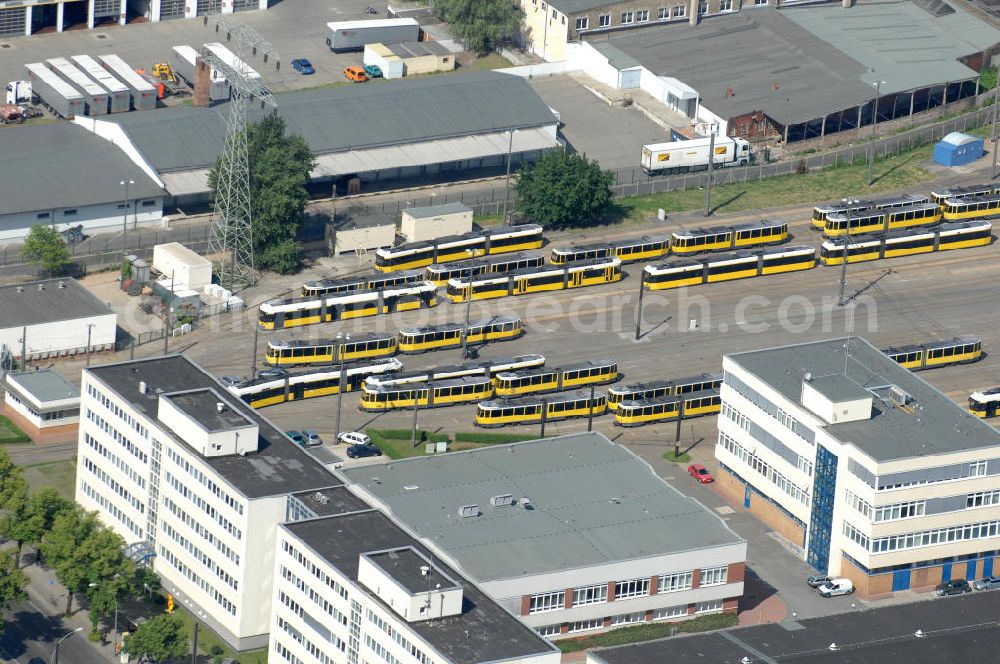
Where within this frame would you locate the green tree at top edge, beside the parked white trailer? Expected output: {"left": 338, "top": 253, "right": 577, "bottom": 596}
{"left": 434, "top": 0, "right": 523, "bottom": 53}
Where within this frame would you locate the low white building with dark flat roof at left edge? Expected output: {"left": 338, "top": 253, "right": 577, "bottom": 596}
{"left": 0, "top": 278, "right": 118, "bottom": 362}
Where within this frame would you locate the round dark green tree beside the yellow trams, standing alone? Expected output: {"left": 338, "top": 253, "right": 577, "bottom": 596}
{"left": 517, "top": 150, "right": 613, "bottom": 228}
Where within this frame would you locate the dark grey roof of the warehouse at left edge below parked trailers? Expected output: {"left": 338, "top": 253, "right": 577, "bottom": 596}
{"left": 0, "top": 123, "right": 165, "bottom": 217}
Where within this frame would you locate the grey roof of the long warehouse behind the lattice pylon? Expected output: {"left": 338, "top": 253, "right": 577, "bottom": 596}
{"left": 103, "top": 72, "right": 557, "bottom": 172}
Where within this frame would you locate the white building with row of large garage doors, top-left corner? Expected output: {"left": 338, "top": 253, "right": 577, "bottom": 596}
{"left": 0, "top": 0, "right": 268, "bottom": 37}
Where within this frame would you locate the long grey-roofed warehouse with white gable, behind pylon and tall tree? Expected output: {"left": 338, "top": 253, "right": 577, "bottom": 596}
{"left": 79, "top": 72, "right": 560, "bottom": 207}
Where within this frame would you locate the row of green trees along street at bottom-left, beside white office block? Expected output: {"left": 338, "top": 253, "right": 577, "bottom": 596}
{"left": 0, "top": 449, "right": 187, "bottom": 662}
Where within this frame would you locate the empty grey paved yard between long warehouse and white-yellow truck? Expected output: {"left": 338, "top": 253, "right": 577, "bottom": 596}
{"left": 529, "top": 76, "right": 667, "bottom": 169}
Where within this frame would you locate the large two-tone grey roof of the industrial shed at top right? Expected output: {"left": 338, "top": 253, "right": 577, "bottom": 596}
{"left": 612, "top": 2, "right": 988, "bottom": 125}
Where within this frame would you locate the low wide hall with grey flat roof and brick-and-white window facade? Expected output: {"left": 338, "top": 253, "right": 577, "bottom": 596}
{"left": 341, "top": 433, "right": 746, "bottom": 638}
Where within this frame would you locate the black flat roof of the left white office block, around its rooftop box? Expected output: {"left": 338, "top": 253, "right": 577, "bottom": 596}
{"left": 84, "top": 355, "right": 334, "bottom": 499}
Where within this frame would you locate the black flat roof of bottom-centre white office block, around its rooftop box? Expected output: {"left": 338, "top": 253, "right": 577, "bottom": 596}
{"left": 282, "top": 510, "right": 555, "bottom": 664}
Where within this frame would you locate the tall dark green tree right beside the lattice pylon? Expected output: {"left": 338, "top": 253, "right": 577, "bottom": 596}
{"left": 208, "top": 115, "right": 314, "bottom": 274}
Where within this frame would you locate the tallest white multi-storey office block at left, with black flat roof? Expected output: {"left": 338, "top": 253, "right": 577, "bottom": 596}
{"left": 76, "top": 356, "right": 334, "bottom": 650}
